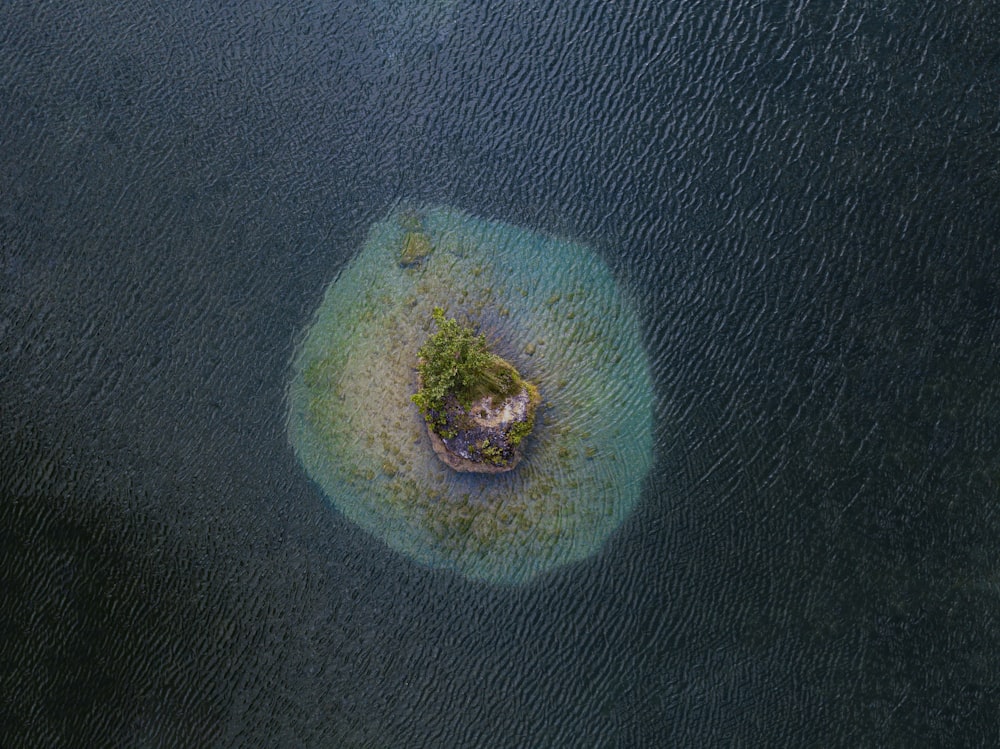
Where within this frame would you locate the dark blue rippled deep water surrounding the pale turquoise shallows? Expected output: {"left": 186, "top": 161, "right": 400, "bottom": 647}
{"left": 0, "top": 0, "right": 1000, "bottom": 747}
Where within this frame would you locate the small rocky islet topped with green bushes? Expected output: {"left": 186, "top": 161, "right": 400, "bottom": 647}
{"left": 412, "top": 307, "right": 541, "bottom": 473}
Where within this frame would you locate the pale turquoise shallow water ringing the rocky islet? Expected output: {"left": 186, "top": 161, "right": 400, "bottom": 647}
{"left": 288, "top": 208, "right": 653, "bottom": 584}
